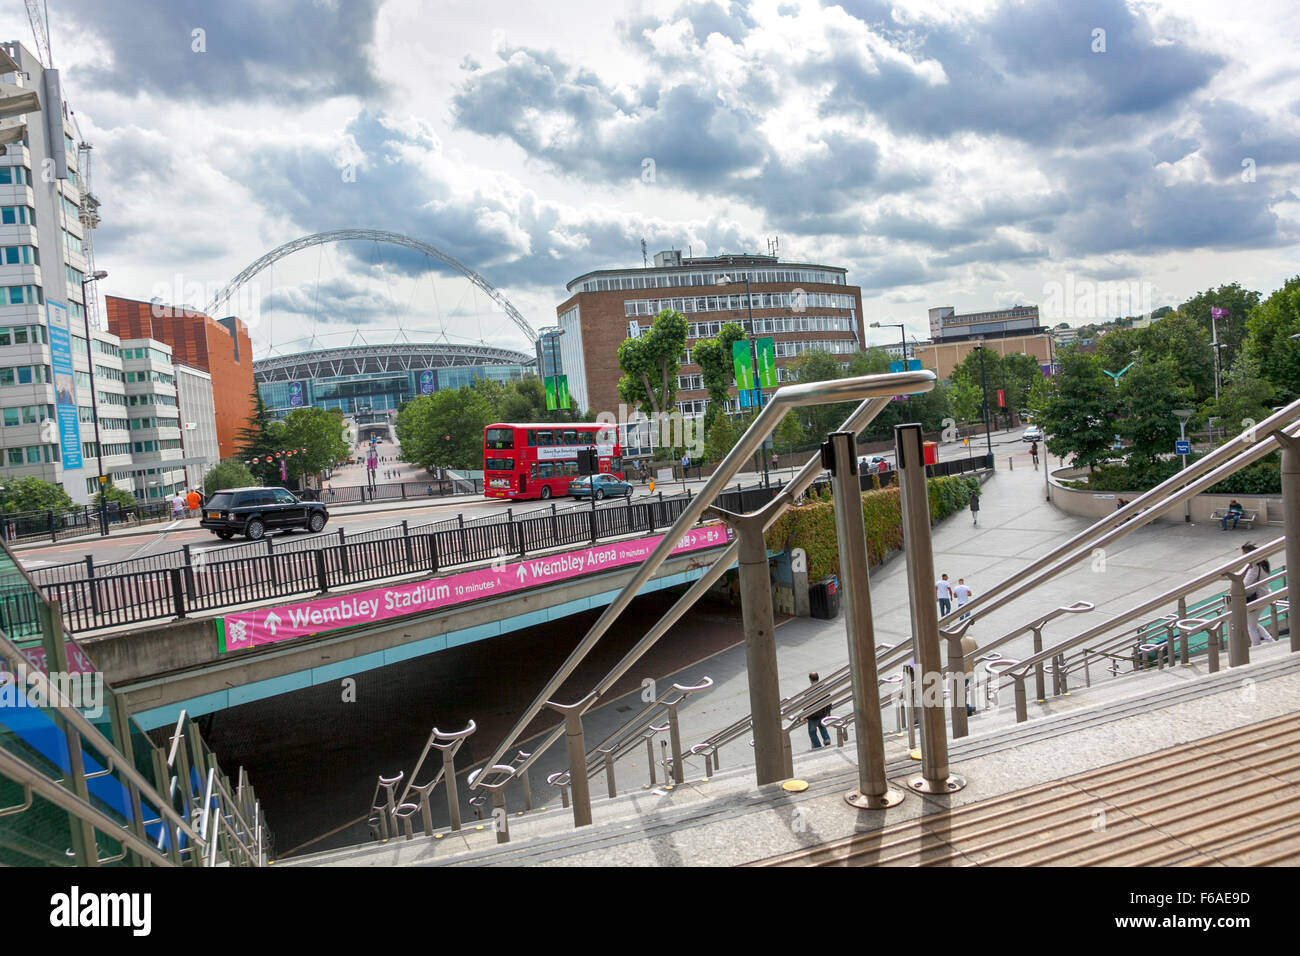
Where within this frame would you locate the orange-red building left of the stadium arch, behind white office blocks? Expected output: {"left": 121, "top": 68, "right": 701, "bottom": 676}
{"left": 104, "top": 295, "right": 256, "bottom": 459}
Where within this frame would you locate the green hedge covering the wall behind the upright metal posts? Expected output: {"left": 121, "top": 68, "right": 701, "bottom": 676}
{"left": 767, "top": 475, "right": 979, "bottom": 581}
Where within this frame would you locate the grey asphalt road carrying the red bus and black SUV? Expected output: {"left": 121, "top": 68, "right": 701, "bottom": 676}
{"left": 17, "top": 428, "right": 1028, "bottom": 568}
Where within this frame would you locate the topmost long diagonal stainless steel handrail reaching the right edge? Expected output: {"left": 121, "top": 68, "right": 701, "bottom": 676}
{"left": 940, "top": 401, "right": 1300, "bottom": 626}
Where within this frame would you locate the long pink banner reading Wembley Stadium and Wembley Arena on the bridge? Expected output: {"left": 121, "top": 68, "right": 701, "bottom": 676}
{"left": 217, "top": 524, "right": 732, "bottom": 654}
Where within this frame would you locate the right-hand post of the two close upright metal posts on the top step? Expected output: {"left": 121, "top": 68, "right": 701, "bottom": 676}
{"left": 894, "top": 424, "right": 966, "bottom": 793}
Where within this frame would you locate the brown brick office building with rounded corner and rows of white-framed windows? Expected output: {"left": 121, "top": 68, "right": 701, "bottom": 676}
{"left": 547, "top": 251, "right": 865, "bottom": 415}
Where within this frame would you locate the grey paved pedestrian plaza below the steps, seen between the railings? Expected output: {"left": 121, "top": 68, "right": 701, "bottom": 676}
{"left": 269, "top": 445, "right": 1263, "bottom": 848}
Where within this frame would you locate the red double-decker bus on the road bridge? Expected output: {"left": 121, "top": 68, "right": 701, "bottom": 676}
{"left": 484, "top": 421, "right": 623, "bottom": 499}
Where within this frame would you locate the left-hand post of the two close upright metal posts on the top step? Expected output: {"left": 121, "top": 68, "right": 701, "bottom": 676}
{"left": 821, "top": 432, "right": 904, "bottom": 810}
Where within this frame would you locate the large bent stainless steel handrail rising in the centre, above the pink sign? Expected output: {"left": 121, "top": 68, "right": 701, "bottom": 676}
{"left": 471, "top": 371, "right": 936, "bottom": 787}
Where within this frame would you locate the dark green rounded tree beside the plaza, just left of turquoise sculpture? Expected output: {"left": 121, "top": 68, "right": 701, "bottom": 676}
{"left": 1037, "top": 349, "right": 1118, "bottom": 471}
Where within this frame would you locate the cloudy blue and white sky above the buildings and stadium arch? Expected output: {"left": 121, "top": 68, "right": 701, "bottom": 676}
{"left": 10, "top": 0, "right": 1300, "bottom": 349}
